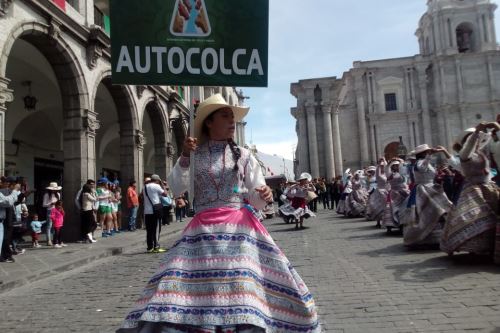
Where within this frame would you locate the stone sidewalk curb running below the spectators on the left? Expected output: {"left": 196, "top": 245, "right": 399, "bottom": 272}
{"left": 0, "top": 229, "right": 183, "bottom": 294}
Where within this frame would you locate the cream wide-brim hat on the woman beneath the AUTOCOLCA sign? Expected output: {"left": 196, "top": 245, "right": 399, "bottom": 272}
{"left": 194, "top": 94, "right": 250, "bottom": 144}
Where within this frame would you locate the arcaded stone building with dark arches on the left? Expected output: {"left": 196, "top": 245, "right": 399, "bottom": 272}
{"left": 0, "top": 0, "right": 245, "bottom": 238}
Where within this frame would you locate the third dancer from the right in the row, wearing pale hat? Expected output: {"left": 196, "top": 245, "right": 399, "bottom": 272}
{"left": 382, "top": 158, "right": 410, "bottom": 232}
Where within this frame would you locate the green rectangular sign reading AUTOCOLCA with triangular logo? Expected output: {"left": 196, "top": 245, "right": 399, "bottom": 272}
{"left": 111, "top": 0, "right": 269, "bottom": 87}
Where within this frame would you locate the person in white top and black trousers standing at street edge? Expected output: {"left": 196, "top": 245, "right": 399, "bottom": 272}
{"left": 144, "top": 175, "right": 167, "bottom": 253}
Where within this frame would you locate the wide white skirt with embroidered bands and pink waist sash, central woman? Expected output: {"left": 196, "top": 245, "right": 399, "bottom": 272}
{"left": 119, "top": 208, "right": 321, "bottom": 333}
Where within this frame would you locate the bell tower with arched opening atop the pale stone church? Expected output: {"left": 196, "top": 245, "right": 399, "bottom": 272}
{"left": 415, "top": 0, "right": 497, "bottom": 56}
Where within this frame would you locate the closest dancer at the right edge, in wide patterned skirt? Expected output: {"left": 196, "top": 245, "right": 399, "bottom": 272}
{"left": 441, "top": 124, "right": 500, "bottom": 263}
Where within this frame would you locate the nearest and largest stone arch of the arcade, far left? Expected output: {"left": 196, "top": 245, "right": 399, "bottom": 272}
{"left": 0, "top": 21, "right": 91, "bottom": 240}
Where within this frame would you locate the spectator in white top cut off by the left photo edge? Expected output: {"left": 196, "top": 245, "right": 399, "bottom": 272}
{"left": 0, "top": 177, "right": 20, "bottom": 263}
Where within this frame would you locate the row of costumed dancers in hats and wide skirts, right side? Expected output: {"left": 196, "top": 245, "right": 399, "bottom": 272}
{"left": 337, "top": 122, "right": 500, "bottom": 263}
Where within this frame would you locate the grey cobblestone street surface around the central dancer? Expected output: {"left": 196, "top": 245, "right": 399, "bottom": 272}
{"left": 0, "top": 210, "right": 500, "bottom": 333}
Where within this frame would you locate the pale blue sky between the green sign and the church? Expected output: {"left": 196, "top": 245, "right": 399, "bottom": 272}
{"left": 243, "top": 0, "right": 500, "bottom": 160}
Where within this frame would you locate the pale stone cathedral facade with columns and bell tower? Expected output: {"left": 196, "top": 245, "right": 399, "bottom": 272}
{"left": 291, "top": 0, "right": 500, "bottom": 178}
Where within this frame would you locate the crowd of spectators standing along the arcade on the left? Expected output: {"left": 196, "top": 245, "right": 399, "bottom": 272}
{"left": 0, "top": 171, "right": 193, "bottom": 263}
